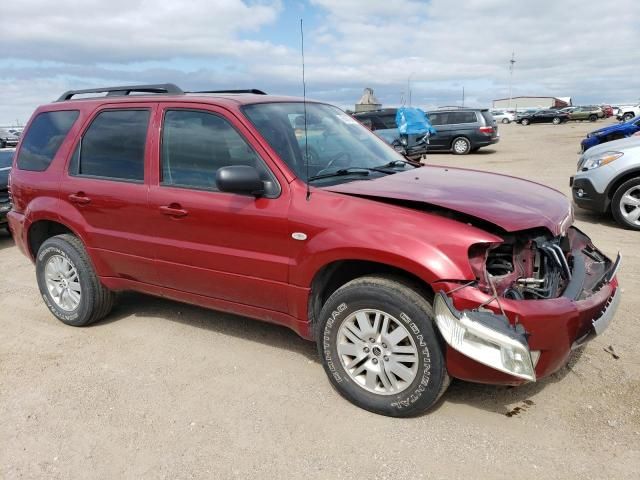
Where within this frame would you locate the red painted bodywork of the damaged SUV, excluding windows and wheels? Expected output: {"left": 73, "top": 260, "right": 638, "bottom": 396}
{"left": 8, "top": 95, "right": 617, "bottom": 384}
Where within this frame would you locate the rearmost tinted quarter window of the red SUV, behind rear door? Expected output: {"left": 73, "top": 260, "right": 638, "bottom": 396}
{"left": 18, "top": 110, "right": 80, "bottom": 172}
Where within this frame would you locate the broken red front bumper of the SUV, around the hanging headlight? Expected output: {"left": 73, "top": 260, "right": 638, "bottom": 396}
{"left": 435, "top": 229, "right": 621, "bottom": 385}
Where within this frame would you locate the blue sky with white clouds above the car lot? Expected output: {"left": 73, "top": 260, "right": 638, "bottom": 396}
{"left": 0, "top": 0, "right": 640, "bottom": 125}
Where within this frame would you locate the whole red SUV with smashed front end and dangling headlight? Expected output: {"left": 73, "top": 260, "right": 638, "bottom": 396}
{"left": 9, "top": 84, "right": 620, "bottom": 416}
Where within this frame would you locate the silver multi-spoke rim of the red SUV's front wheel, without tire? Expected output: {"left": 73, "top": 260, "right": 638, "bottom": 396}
{"left": 338, "top": 309, "right": 418, "bottom": 395}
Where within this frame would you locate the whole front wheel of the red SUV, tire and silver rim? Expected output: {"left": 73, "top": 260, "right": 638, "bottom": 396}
{"left": 316, "top": 276, "right": 449, "bottom": 417}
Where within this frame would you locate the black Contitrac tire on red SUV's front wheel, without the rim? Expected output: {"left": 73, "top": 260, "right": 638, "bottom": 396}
{"left": 316, "top": 276, "right": 449, "bottom": 417}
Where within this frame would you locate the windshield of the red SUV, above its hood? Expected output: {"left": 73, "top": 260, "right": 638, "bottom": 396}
{"left": 243, "top": 102, "right": 405, "bottom": 181}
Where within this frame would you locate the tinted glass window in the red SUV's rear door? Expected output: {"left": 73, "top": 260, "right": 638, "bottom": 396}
{"left": 69, "top": 110, "right": 149, "bottom": 182}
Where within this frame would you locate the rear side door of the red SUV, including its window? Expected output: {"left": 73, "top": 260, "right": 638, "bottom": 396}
{"left": 60, "top": 104, "right": 155, "bottom": 282}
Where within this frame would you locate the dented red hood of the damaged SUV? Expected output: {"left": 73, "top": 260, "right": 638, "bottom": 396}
{"left": 324, "top": 166, "right": 573, "bottom": 236}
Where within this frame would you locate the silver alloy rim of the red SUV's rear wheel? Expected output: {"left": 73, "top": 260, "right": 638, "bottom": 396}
{"left": 44, "top": 255, "right": 82, "bottom": 312}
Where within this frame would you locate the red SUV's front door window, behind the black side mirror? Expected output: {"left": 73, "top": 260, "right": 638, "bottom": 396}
{"left": 161, "top": 110, "right": 272, "bottom": 190}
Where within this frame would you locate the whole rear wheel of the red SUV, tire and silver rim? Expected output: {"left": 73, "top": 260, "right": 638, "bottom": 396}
{"left": 36, "top": 234, "right": 114, "bottom": 327}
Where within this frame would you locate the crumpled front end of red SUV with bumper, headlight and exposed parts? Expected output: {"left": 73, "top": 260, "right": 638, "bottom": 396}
{"left": 434, "top": 227, "right": 620, "bottom": 385}
